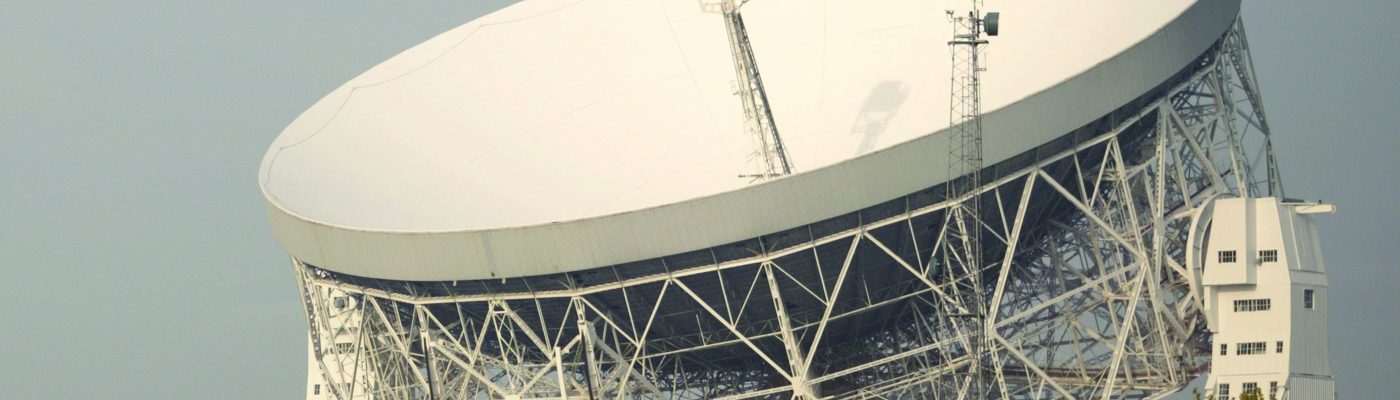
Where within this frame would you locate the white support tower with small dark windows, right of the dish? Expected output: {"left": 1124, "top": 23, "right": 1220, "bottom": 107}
{"left": 1196, "top": 197, "right": 1336, "bottom": 400}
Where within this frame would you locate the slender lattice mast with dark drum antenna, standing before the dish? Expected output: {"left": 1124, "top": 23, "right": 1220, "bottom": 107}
{"left": 942, "top": 0, "right": 1000, "bottom": 399}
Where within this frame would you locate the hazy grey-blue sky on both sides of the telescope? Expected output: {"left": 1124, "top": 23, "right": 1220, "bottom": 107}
{"left": 0, "top": 0, "right": 1400, "bottom": 399}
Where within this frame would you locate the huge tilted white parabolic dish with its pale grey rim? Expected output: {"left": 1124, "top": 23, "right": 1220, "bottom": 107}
{"left": 259, "top": 0, "right": 1239, "bottom": 281}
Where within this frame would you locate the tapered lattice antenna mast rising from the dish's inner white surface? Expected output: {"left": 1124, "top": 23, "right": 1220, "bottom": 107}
{"left": 700, "top": 0, "right": 792, "bottom": 180}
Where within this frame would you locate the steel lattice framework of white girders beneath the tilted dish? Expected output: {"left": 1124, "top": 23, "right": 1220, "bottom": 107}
{"left": 294, "top": 21, "right": 1282, "bottom": 399}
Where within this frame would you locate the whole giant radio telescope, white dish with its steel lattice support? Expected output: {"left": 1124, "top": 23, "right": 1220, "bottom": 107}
{"left": 259, "top": 0, "right": 1330, "bottom": 399}
